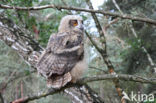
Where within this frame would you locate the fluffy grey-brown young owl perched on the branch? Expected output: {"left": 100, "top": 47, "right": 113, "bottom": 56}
{"left": 36, "top": 15, "right": 87, "bottom": 88}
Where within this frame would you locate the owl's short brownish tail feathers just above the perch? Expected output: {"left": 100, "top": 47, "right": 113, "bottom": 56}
{"left": 47, "top": 72, "right": 72, "bottom": 88}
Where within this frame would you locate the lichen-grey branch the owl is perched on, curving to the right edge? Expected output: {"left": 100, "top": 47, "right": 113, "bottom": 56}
{"left": 10, "top": 74, "right": 156, "bottom": 103}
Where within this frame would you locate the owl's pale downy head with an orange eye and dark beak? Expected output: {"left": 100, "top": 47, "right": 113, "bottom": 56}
{"left": 59, "top": 15, "right": 84, "bottom": 32}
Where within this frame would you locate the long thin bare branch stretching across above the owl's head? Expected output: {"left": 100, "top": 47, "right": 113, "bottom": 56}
{"left": 0, "top": 4, "right": 156, "bottom": 25}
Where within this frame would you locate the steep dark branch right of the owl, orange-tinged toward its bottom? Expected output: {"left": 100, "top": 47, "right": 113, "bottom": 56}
{"left": 86, "top": 0, "right": 126, "bottom": 103}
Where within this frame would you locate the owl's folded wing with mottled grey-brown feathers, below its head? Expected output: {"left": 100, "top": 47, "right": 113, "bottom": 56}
{"left": 37, "top": 33, "right": 83, "bottom": 87}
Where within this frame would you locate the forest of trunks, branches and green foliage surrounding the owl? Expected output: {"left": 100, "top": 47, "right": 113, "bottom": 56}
{"left": 0, "top": 0, "right": 156, "bottom": 103}
